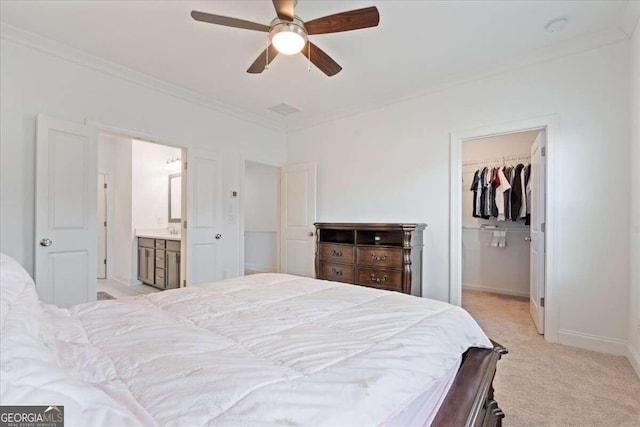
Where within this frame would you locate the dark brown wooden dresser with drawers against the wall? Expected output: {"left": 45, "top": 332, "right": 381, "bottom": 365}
{"left": 315, "top": 222, "right": 426, "bottom": 296}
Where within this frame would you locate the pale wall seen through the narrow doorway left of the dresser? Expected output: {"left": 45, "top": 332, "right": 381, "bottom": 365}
{"left": 243, "top": 161, "right": 280, "bottom": 273}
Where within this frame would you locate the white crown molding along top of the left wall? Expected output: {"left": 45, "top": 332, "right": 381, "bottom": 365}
{"left": 0, "top": 22, "right": 284, "bottom": 132}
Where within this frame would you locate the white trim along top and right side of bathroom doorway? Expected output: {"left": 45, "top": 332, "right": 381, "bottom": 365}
{"left": 85, "top": 118, "right": 191, "bottom": 287}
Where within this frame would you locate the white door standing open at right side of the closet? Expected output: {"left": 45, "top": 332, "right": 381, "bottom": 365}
{"left": 529, "top": 131, "right": 546, "bottom": 334}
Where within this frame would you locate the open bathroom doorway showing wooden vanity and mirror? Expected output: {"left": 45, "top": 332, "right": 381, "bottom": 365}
{"left": 98, "top": 132, "right": 185, "bottom": 298}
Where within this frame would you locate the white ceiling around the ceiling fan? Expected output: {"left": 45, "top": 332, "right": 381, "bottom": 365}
{"left": 0, "top": 0, "right": 638, "bottom": 127}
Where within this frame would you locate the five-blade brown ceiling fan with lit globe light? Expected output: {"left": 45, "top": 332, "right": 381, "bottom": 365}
{"left": 191, "top": 0, "right": 380, "bottom": 76}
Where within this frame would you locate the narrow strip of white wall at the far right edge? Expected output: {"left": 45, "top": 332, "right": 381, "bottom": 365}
{"left": 629, "top": 20, "right": 640, "bottom": 376}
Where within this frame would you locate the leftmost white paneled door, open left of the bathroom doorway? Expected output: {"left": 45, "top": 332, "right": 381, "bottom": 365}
{"left": 35, "top": 116, "right": 98, "bottom": 307}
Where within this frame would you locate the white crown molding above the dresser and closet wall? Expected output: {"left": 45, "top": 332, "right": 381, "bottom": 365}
{"left": 286, "top": 28, "right": 629, "bottom": 133}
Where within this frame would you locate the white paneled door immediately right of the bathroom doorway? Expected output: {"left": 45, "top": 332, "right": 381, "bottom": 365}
{"left": 182, "top": 148, "right": 223, "bottom": 285}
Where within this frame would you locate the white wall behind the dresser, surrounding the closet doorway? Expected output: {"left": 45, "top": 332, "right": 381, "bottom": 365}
{"left": 287, "top": 41, "right": 630, "bottom": 352}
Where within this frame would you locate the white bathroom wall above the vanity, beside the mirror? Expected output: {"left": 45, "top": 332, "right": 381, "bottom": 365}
{"left": 131, "top": 140, "right": 182, "bottom": 230}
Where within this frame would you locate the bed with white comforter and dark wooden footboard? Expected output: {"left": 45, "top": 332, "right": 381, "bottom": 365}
{"left": 0, "top": 255, "right": 505, "bottom": 426}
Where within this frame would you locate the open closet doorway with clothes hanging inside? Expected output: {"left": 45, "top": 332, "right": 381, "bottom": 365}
{"left": 451, "top": 119, "right": 556, "bottom": 339}
